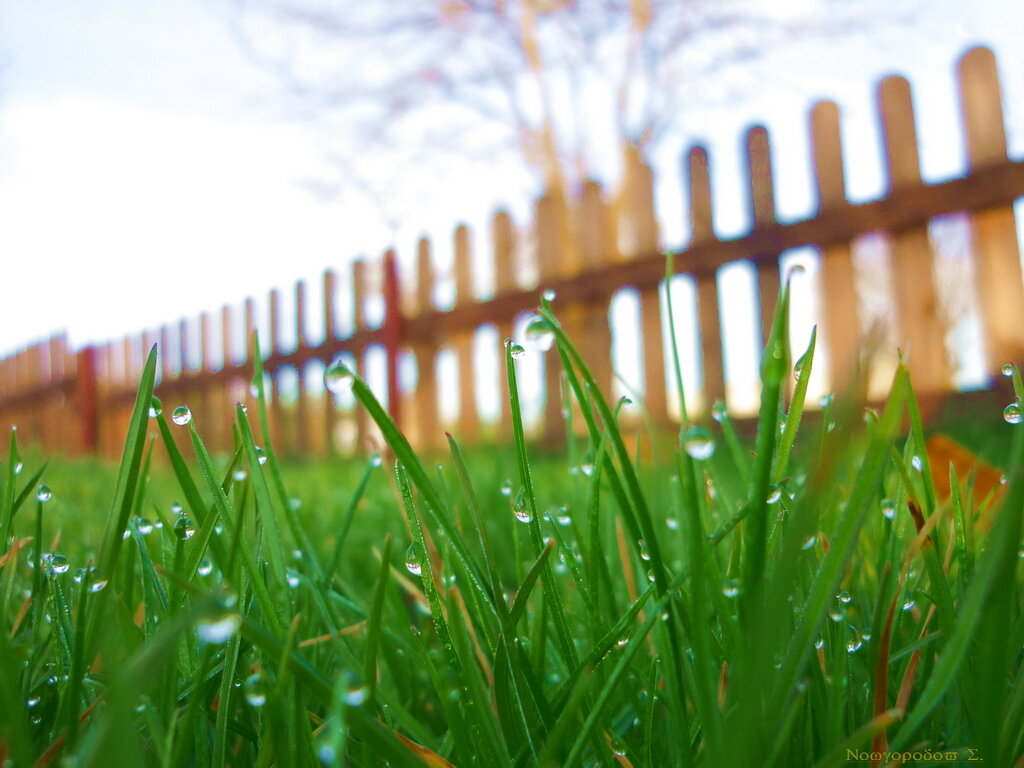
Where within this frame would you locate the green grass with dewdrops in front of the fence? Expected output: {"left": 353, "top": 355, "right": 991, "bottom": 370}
{"left": 0, "top": 284, "right": 1024, "bottom": 768}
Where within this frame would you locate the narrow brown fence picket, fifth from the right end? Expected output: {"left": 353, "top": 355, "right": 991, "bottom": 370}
{"left": 687, "top": 146, "right": 725, "bottom": 408}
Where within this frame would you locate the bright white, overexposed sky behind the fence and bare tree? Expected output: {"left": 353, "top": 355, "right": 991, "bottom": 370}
{"left": 0, "top": 0, "right": 1024, "bottom": 415}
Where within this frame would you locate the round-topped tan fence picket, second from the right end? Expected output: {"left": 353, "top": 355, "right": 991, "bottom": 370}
{"left": 879, "top": 77, "right": 950, "bottom": 392}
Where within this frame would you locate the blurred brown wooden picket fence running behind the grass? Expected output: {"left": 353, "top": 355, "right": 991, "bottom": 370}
{"left": 0, "top": 48, "right": 1024, "bottom": 456}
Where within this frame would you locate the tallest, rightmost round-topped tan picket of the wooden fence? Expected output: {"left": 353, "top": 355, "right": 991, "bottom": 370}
{"left": 957, "top": 48, "right": 1024, "bottom": 376}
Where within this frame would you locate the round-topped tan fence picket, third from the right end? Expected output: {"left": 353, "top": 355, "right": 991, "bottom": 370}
{"left": 811, "top": 101, "right": 861, "bottom": 389}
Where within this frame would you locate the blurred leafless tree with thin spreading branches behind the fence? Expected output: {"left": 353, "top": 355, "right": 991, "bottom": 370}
{"left": 238, "top": 0, "right": 913, "bottom": 231}
